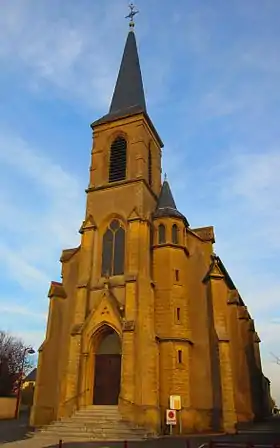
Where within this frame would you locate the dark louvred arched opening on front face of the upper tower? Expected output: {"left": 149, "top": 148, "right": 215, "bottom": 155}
{"left": 109, "top": 137, "right": 127, "bottom": 182}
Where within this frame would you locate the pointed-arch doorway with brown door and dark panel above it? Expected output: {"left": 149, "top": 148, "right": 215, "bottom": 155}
{"left": 93, "top": 326, "right": 121, "bottom": 405}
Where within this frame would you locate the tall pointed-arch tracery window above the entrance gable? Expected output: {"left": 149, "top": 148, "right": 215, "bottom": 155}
{"left": 102, "top": 219, "right": 125, "bottom": 276}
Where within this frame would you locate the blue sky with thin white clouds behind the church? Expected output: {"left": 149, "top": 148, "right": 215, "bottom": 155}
{"left": 0, "top": 0, "right": 280, "bottom": 404}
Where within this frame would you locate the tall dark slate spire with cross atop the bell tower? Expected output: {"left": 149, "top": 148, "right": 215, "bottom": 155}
{"left": 109, "top": 4, "right": 146, "bottom": 114}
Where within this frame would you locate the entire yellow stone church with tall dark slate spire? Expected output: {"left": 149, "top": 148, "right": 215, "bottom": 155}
{"left": 31, "top": 11, "right": 269, "bottom": 434}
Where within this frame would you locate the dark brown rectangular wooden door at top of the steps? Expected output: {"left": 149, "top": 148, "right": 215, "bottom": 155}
{"left": 93, "top": 355, "right": 121, "bottom": 405}
